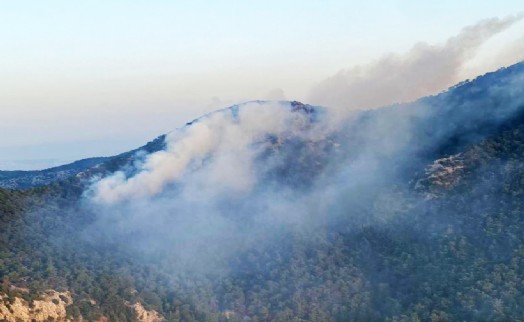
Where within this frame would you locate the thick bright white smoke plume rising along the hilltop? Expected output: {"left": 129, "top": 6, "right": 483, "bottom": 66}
{"left": 91, "top": 102, "right": 324, "bottom": 203}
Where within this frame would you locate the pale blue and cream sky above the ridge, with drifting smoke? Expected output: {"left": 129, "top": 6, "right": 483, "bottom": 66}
{"left": 0, "top": 0, "right": 524, "bottom": 170}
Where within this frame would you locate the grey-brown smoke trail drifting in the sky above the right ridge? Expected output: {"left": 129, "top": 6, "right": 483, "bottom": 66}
{"left": 309, "top": 14, "right": 523, "bottom": 110}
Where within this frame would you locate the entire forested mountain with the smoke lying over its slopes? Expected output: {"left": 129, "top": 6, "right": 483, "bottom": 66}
{"left": 0, "top": 63, "right": 524, "bottom": 321}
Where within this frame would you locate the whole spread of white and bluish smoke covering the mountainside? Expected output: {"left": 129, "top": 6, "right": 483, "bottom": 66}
{"left": 79, "top": 59, "right": 524, "bottom": 275}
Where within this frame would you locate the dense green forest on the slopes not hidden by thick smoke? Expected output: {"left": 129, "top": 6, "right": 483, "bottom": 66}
{"left": 0, "top": 63, "right": 524, "bottom": 321}
